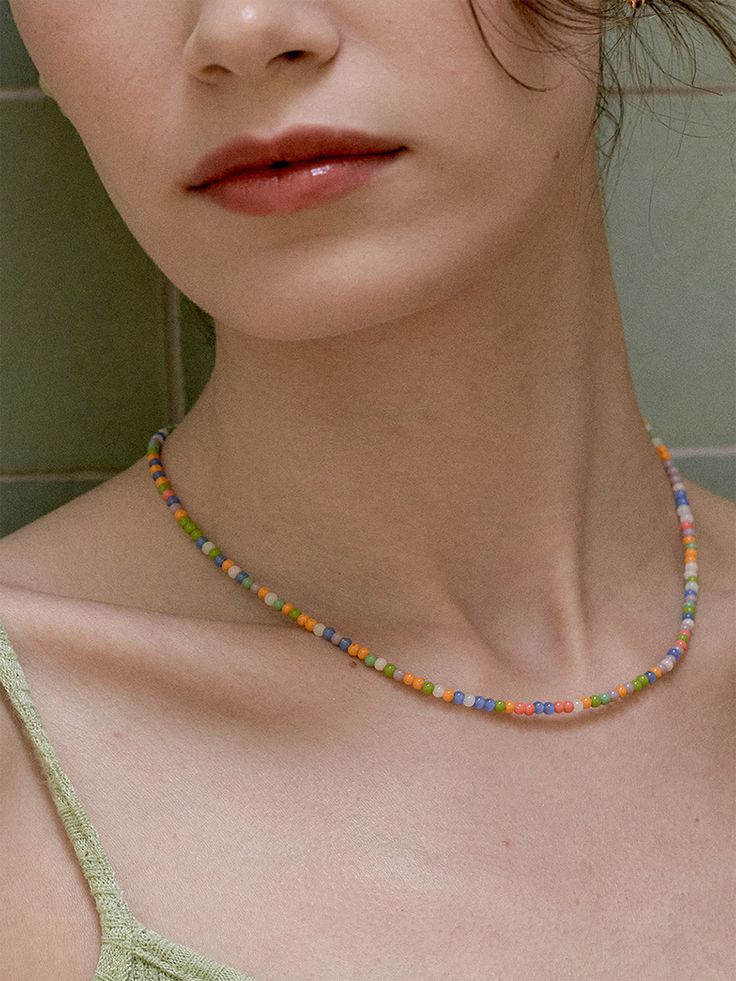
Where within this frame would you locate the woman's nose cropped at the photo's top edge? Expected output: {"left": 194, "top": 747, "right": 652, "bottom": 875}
{"left": 183, "top": 0, "right": 340, "bottom": 85}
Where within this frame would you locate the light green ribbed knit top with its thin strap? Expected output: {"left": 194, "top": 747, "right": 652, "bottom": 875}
{"left": 0, "top": 623, "right": 256, "bottom": 981}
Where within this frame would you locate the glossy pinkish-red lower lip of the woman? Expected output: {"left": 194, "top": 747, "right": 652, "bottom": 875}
{"left": 193, "top": 148, "right": 403, "bottom": 215}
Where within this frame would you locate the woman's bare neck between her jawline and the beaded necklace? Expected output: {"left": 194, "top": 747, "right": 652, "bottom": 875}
{"left": 162, "top": 186, "right": 684, "bottom": 685}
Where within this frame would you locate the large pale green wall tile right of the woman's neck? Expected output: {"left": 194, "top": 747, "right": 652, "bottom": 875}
{"left": 606, "top": 95, "right": 736, "bottom": 446}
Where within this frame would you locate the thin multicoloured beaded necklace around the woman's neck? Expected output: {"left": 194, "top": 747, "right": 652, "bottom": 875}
{"left": 146, "top": 417, "right": 700, "bottom": 718}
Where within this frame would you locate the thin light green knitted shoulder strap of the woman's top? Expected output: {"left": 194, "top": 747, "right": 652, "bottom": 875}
{"left": 0, "top": 623, "right": 133, "bottom": 943}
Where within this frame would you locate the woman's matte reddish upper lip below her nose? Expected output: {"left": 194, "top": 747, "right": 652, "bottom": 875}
{"left": 186, "top": 126, "right": 405, "bottom": 189}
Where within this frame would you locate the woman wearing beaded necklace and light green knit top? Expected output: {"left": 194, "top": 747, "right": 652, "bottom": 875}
{"left": 0, "top": 0, "right": 736, "bottom": 981}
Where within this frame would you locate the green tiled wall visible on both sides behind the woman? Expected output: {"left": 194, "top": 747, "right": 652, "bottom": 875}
{"left": 0, "top": 0, "right": 736, "bottom": 536}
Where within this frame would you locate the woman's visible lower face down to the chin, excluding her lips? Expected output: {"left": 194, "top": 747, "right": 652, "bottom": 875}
{"left": 11, "top": 0, "right": 598, "bottom": 340}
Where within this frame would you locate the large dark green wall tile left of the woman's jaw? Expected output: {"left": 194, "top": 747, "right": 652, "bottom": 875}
{"left": 0, "top": 99, "right": 167, "bottom": 473}
